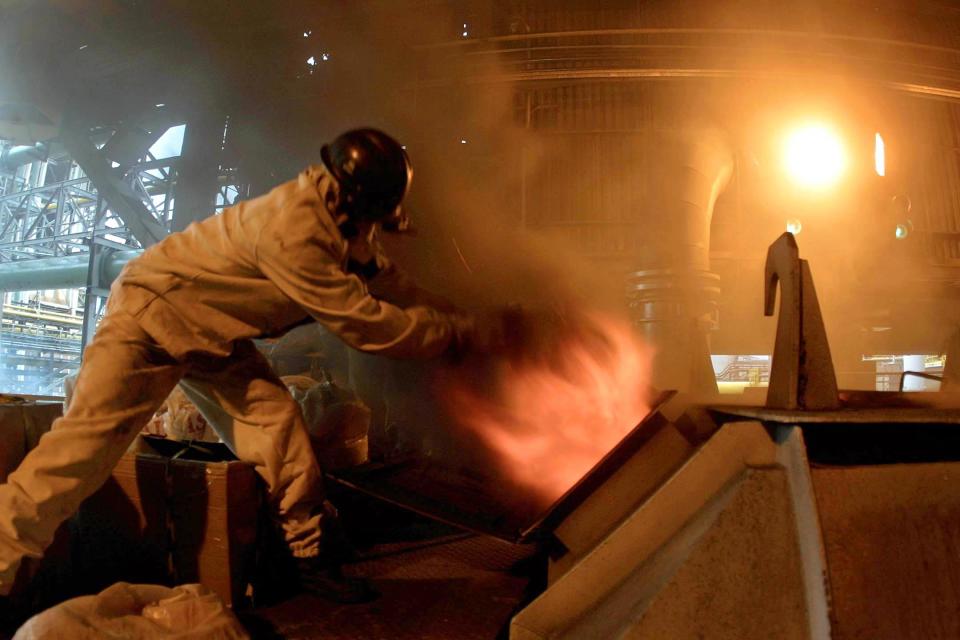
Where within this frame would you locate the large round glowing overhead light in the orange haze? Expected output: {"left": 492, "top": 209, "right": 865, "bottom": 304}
{"left": 783, "top": 124, "right": 847, "bottom": 189}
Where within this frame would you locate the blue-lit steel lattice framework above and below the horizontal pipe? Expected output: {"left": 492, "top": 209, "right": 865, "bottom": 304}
{"left": 0, "top": 121, "right": 179, "bottom": 395}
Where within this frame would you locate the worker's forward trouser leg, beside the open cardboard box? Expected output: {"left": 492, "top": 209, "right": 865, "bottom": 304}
{"left": 180, "top": 341, "right": 326, "bottom": 558}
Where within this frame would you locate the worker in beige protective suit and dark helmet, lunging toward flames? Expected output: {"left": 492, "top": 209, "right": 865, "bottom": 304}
{"left": 0, "top": 129, "right": 484, "bottom": 601}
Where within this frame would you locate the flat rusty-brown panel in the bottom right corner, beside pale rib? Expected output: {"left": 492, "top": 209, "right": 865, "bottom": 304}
{"left": 812, "top": 463, "right": 960, "bottom": 640}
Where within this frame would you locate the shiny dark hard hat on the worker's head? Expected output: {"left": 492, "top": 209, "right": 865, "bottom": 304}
{"left": 320, "top": 129, "right": 413, "bottom": 220}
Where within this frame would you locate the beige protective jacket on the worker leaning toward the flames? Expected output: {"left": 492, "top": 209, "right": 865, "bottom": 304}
{"left": 111, "top": 166, "right": 457, "bottom": 359}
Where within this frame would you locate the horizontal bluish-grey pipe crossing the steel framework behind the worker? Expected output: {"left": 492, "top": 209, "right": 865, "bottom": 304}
{"left": 0, "top": 250, "right": 142, "bottom": 291}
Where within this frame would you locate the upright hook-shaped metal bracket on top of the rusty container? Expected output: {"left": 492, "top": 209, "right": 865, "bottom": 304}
{"left": 764, "top": 233, "right": 840, "bottom": 410}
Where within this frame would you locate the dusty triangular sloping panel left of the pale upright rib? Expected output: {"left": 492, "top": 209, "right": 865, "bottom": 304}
{"left": 626, "top": 470, "right": 808, "bottom": 640}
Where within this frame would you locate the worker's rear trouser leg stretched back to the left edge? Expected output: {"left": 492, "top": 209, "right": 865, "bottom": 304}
{"left": 0, "top": 312, "right": 183, "bottom": 593}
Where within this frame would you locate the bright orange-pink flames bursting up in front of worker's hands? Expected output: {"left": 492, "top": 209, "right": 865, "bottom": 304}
{"left": 447, "top": 316, "right": 652, "bottom": 505}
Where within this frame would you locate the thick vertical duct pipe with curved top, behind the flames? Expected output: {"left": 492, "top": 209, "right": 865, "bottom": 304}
{"left": 627, "top": 129, "right": 733, "bottom": 393}
